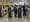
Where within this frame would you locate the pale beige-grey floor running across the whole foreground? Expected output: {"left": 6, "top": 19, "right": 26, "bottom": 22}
{"left": 0, "top": 15, "right": 30, "bottom": 22}
